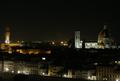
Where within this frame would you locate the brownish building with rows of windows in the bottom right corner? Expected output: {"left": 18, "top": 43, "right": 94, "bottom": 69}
{"left": 96, "top": 66, "right": 120, "bottom": 81}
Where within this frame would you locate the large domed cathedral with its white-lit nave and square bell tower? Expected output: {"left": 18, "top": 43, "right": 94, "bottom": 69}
{"left": 69, "top": 25, "right": 117, "bottom": 49}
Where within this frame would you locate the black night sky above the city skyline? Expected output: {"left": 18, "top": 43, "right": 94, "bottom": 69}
{"left": 0, "top": 0, "right": 117, "bottom": 40}
